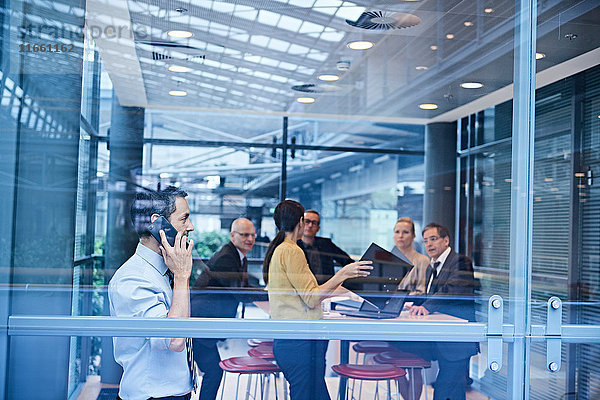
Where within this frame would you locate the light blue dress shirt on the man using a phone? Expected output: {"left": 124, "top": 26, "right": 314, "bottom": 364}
{"left": 108, "top": 243, "right": 192, "bottom": 400}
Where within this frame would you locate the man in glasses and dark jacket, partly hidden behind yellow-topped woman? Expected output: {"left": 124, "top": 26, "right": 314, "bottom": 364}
{"left": 298, "top": 210, "right": 354, "bottom": 285}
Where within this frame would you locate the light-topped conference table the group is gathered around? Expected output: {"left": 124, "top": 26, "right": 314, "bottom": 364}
{"left": 253, "top": 287, "right": 468, "bottom": 398}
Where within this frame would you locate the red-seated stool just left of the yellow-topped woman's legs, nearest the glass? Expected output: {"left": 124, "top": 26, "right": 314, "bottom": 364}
{"left": 219, "top": 357, "right": 281, "bottom": 400}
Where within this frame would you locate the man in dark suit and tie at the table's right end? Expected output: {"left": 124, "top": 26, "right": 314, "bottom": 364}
{"left": 394, "top": 223, "right": 479, "bottom": 400}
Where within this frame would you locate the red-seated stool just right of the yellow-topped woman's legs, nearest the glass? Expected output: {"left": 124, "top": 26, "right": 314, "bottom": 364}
{"left": 331, "top": 364, "right": 406, "bottom": 400}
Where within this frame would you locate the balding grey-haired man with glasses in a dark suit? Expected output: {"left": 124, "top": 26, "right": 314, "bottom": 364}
{"left": 191, "top": 218, "right": 256, "bottom": 400}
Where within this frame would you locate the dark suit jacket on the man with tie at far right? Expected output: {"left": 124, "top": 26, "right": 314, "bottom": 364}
{"left": 422, "top": 250, "right": 479, "bottom": 360}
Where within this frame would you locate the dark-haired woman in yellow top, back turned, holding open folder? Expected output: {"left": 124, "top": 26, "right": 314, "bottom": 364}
{"left": 263, "top": 200, "right": 373, "bottom": 400}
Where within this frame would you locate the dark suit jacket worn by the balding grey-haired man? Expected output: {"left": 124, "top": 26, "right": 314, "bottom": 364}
{"left": 190, "top": 242, "right": 243, "bottom": 318}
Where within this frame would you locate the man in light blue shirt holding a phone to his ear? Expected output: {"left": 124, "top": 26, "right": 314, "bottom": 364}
{"left": 108, "top": 186, "right": 195, "bottom": 400}
